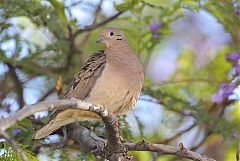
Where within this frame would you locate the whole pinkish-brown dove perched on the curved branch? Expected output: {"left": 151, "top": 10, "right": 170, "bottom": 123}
{"left": 33, "top": 28, "right": 144, "bottom": 139}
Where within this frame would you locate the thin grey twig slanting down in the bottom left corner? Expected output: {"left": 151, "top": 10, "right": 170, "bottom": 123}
{"left": 0, "top": 130, "right": 28, "bottom": 161}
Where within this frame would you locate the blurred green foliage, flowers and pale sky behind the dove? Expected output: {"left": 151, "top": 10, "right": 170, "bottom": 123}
{"left": 0, "top": 0, "right": 240, "bottom": 161}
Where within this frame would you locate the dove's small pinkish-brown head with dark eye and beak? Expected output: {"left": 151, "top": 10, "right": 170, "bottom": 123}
{"left": 97, "top": 28, "right": 127, "bottom": 47}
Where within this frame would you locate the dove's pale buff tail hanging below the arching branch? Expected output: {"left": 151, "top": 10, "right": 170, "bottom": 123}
{"left": 33, "top": 109, "right": 100, "bottom": 139}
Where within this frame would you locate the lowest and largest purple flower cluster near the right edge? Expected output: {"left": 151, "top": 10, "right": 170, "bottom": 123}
{"left": 212, "top": 83, "right": 236, "bottom": 103}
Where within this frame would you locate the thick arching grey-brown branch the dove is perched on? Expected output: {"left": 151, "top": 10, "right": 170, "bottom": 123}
{"left": 0, "top": 100, "right": 214, "bottom": 161}
